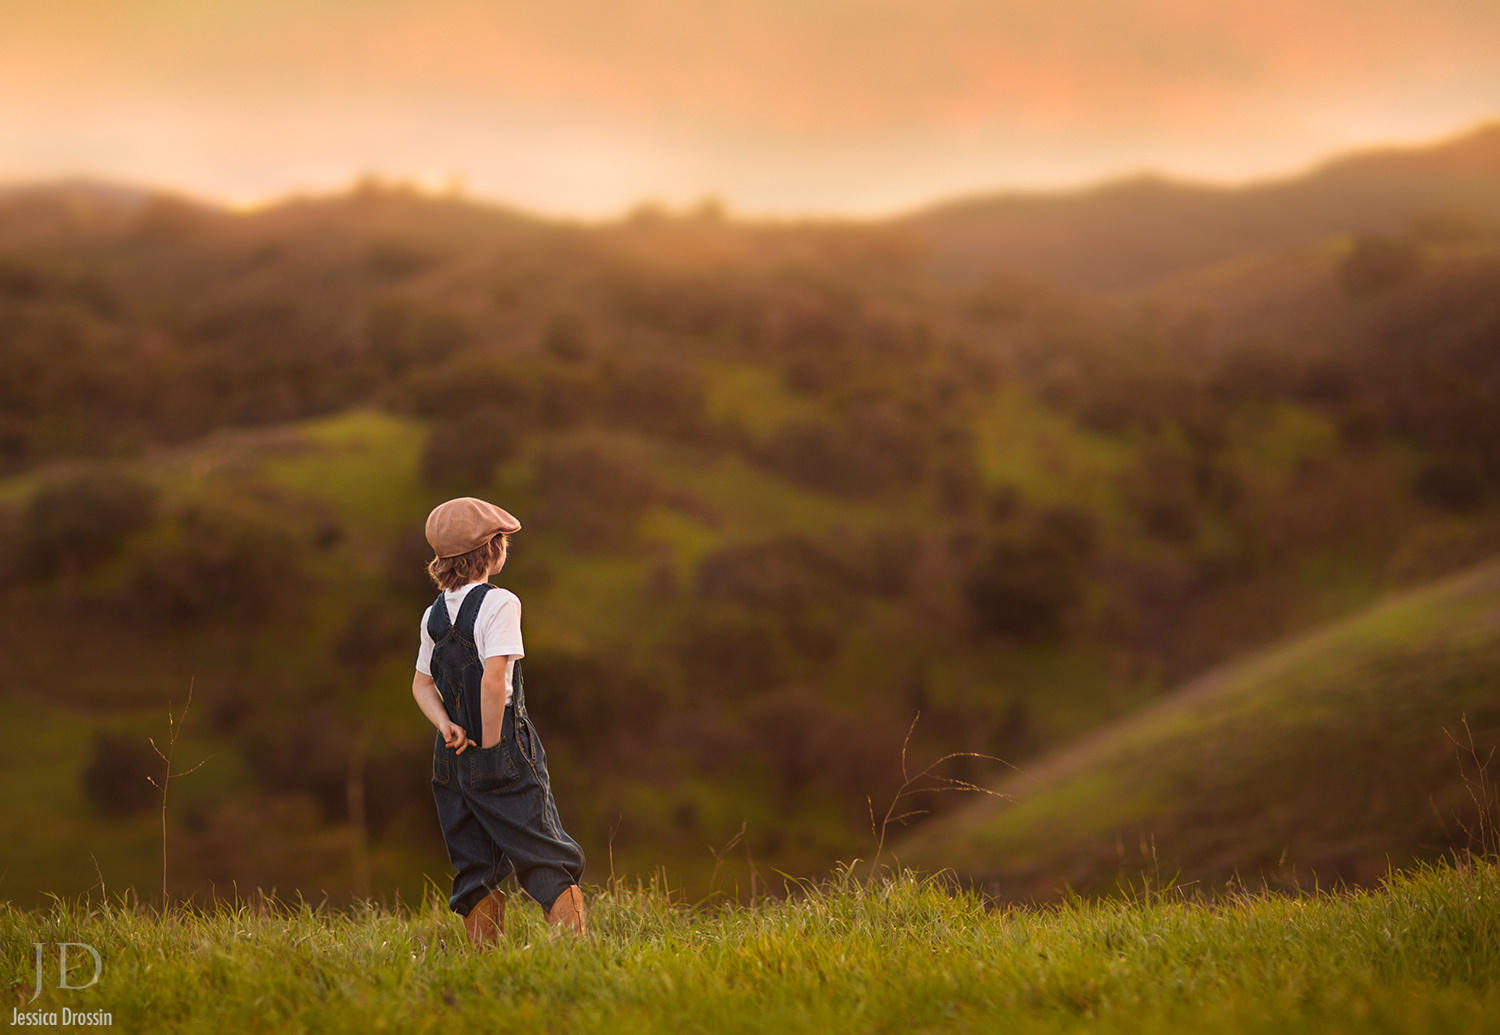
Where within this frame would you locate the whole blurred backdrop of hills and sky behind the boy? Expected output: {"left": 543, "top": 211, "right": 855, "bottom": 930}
{"left": 0, "top": 0, "right": 1500, "bottom": 905}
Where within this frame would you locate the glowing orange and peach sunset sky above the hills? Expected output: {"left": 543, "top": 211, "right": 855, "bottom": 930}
{"left": 0, "top": 0, "right": 1500, "bottom": 219}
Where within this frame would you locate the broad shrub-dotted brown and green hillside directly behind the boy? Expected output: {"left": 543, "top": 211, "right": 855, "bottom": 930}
{"left": 0, "top": 125, "right": 1500, "bottom": 902}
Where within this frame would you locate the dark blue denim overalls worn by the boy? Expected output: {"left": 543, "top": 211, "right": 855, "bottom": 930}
{"left": 428, "top": 582, "right": 584, "bottom": 915}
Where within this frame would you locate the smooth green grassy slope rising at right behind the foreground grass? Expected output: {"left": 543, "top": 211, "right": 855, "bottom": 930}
{"left": 896, "top": 561, "right": 1500, "bottom": 897}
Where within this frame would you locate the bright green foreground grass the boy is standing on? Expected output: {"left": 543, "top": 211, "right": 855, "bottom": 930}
{"left": 0, "top": 860, "right": 1500, "bottom": 1035}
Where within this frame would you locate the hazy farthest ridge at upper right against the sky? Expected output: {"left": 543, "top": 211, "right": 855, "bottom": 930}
{"left": 894, "top": 123, "right": 1500, "bottom": 290}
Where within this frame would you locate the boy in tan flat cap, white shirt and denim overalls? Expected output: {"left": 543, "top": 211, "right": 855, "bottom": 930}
{"left": 411, "top": 497, "right": 585, "bottom": 947}
